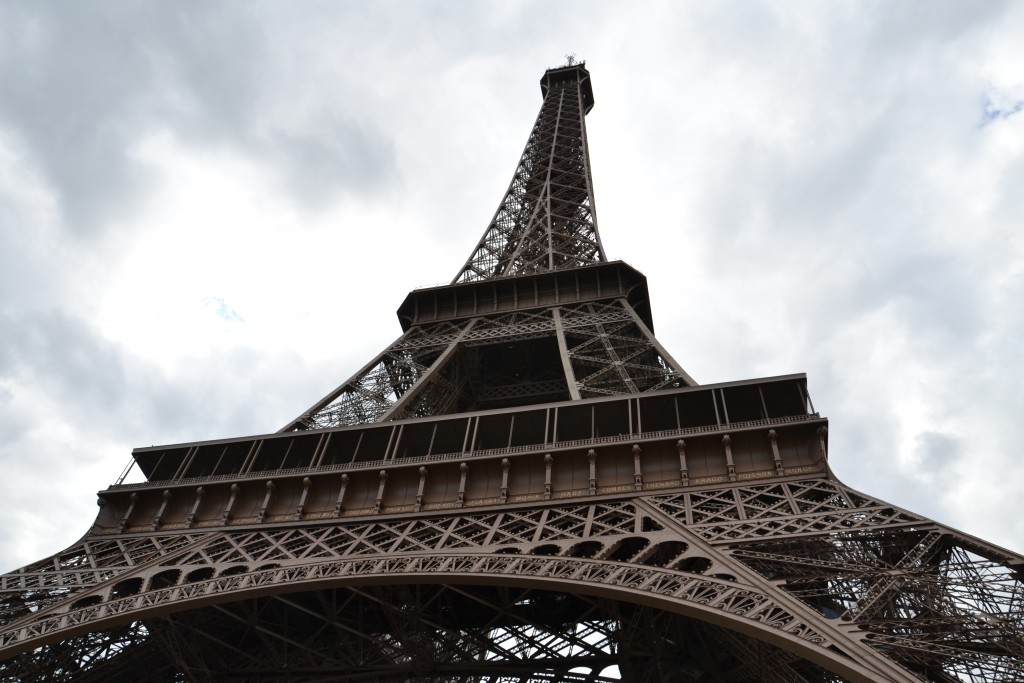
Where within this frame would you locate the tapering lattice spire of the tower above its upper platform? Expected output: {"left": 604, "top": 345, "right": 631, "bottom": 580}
{"left": 452, "top": 59, "right": 606, "bottom": 284}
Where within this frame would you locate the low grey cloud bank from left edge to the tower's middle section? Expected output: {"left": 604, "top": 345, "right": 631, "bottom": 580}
{"left": 0, "top": 310, "right": 319, "bottom": 448}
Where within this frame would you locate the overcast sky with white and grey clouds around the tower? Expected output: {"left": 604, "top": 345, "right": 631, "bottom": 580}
{"left": 0, "top": 0, "right": 1024, "bottom": 570}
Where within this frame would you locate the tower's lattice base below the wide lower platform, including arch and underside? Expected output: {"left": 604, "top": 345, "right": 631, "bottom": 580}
{"left": 0, "top": 477, "right": 1024, "bottom": 681}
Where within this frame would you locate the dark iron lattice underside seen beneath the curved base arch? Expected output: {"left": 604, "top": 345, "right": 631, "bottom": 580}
{"left": 4, "top": 585, "right": 842, "bottom": 683}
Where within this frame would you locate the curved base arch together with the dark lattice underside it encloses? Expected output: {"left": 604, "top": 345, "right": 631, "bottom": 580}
{"left": 0, "top": 554, "right": 915, "bottom": 683}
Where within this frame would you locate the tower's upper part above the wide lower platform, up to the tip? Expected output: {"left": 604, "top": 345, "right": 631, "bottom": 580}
{"left": 281, "top": 58, "right": 696, "bottom": 432}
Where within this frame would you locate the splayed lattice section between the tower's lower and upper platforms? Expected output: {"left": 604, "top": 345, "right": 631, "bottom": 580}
{"left": 282, "top": 299, "right": 695, "bottom": 431}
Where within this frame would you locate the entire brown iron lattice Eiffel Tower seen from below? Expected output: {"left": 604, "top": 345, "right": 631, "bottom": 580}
{"left": 0, "top": 61, "right": 1024, "bottom": 683}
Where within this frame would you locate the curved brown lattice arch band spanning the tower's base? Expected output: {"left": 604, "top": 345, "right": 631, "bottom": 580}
{"left": 0, "top": 553, "right": 914, "bottom": 683}
